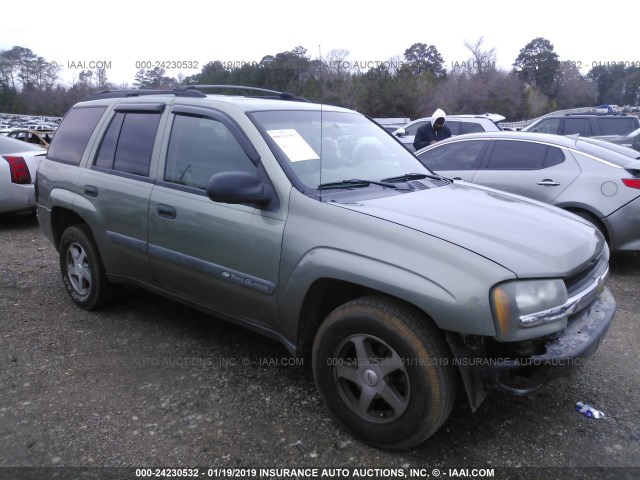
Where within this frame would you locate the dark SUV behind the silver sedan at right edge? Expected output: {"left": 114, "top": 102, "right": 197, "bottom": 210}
{"left": 522, "top": 113, "right": 640, "bottom": 137}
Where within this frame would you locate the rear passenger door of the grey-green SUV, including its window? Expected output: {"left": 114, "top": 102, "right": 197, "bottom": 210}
{"left": 78, "top": 103, "right": 165, "bottom": 284}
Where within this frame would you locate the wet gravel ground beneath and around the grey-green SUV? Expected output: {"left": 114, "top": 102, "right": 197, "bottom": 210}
{"left": 0, "top": 215, "right": 640, "bottom": 479}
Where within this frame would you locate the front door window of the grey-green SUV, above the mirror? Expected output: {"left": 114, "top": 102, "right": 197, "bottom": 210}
{"left": 164, "top": 115, "right": 257, "bottom": 190}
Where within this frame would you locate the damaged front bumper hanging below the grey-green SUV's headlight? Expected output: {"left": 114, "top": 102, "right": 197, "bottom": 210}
{"left": 447, "top": 288, "right": 616, "bottom": 410}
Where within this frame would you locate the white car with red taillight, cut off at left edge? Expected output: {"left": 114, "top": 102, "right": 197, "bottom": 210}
{"left": 0, "top": 136, "right": 47, "bottom": 213}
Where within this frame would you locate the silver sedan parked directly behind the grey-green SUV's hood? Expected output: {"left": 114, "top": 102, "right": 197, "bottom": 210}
{"left": 415, "top": 132, "right": 640, "bottom": 250}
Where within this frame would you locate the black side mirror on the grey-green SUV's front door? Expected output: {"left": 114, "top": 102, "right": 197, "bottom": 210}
{"left": 207, "top": 172, "right": 272, "bottom": 205}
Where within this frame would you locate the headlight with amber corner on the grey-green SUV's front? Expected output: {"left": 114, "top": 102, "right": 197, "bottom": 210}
{"left": 491, "top": 279, "right": 570, "bottom": 341}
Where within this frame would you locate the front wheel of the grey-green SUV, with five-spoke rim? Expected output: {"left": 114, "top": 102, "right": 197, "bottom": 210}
{"left": 312, "top": 296, "right": 456, "bottom": 450}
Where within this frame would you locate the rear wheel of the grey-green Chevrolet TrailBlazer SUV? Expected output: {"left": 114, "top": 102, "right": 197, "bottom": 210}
{"left": 58, "top": 225, "right": 113, "bottom": 310}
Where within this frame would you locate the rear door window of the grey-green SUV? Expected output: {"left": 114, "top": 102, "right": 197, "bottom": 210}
{"left": 93, "top": 112, "right": 160, "bottom": 176}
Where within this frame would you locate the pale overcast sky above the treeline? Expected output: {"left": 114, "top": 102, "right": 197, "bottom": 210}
{"left": 0, "top": 0, "right": 640, "bottom": 85}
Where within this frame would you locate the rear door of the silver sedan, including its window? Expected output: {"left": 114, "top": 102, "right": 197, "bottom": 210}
{"left": 473, "top": 140, "right": 580, "bottom": 203}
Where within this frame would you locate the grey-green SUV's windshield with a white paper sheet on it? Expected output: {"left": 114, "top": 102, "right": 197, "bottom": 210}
{"left": 251, "top": 111, "right": 431, "bottom": 191}
